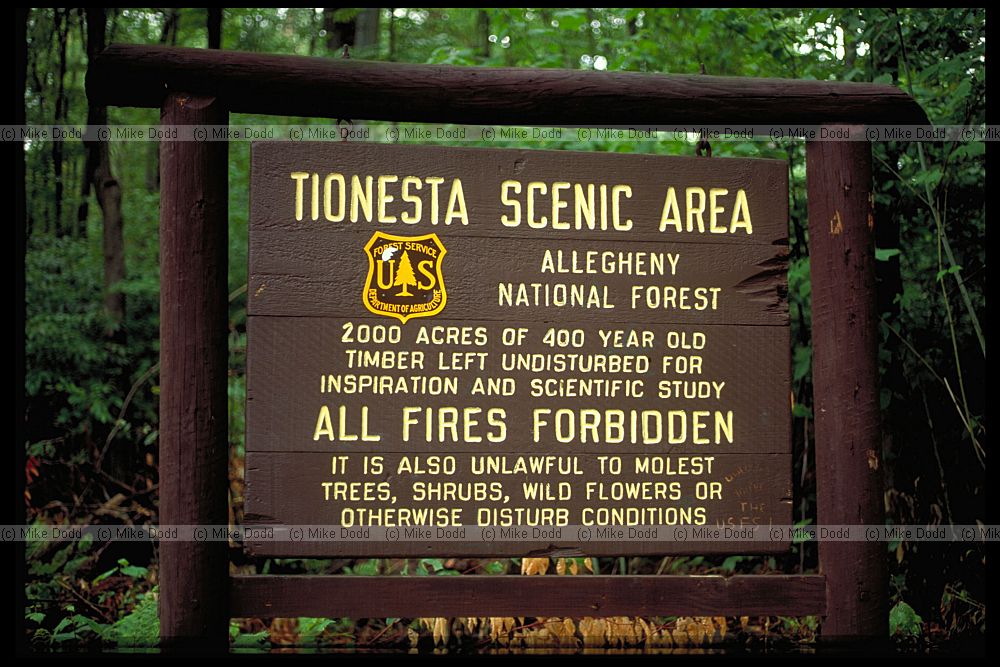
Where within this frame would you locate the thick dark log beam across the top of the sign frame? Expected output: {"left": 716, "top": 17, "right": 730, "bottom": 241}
{"left": 87, "top": 44, "right": 928, "bottom": 127}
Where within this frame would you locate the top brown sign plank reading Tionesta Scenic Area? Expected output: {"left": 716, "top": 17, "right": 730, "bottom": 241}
{"left": 250, "top": 142, "right": 788, "bottom": 245}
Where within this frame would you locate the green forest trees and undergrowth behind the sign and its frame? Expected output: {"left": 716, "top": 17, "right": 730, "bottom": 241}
{"left": 15, "top": 8, "right": 989, "bottom": 649}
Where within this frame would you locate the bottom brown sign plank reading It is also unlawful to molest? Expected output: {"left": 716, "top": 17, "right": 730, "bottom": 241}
{"left": 246, "top": 452, "right": 792, "bottom": 556}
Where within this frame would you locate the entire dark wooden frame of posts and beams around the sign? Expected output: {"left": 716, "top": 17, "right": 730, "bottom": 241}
{"left": 87, "top": 45, "right": 928, "bottom": 651}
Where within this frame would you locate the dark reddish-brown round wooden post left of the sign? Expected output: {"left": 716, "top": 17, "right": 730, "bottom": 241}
{"left": 159, "top": 93, "right": 229, "bottom": 651}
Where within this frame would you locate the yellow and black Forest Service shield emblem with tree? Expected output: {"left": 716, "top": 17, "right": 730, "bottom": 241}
{"left": 362, "top": 232, "right": 448, "bottom": 324}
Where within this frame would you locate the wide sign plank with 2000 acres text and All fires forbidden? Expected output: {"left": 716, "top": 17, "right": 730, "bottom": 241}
{"left": 247, "top": 317, "right": 791, "bottom": 454}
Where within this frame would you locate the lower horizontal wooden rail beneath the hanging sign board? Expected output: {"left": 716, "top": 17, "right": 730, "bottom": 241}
{"left": 230, "top": 575, "right": 826, "bottom": 618}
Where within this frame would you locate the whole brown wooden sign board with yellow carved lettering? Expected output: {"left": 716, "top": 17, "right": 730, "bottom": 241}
{"left": 246, "top": 143, "right": 792, "bottom": 556}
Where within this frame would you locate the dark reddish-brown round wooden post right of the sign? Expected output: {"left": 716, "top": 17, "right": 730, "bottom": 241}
{"left": 806, "top": 126, "right": 888, "bottom": 641}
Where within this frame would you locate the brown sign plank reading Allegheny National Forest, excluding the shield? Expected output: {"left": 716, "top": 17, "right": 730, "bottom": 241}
{"left": 248, "top": 236, "right": 788, "bottom": 325}
